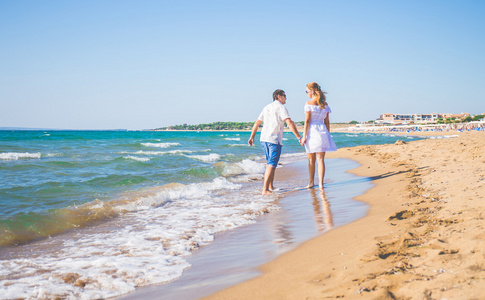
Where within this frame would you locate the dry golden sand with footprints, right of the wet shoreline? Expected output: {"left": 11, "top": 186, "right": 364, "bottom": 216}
{"left": 208, "top": 132, "right": 485, "bottom": 299}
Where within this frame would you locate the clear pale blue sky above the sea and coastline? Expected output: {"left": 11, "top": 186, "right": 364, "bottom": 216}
{"left": 0, "top": 0, "right": 485, "bottom": 129}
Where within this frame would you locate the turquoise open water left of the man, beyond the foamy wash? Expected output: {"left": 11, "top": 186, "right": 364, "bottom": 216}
{"left": 0, "top": 131, "right": 260, "bottom": 246}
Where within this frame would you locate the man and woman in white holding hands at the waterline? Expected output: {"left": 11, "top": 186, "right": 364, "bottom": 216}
{"left": 248, "top": 82, "right": 337, "bottom": 195}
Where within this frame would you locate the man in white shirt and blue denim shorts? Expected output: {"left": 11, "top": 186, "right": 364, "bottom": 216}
{"left": 248, "top": 90, "right": 301, "bottom": 195}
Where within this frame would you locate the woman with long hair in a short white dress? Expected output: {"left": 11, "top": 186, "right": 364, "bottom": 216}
{"left": 301, "top": 82, "right": 337, "bottom": 190}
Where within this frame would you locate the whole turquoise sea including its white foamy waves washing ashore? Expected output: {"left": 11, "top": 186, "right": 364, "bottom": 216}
{"left": 0, "top": 130, "right": 417, "bottom": 299}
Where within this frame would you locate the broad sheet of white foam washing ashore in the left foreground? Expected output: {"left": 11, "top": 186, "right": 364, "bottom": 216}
{"left": 0, "top": 178, "right": 278, "bottom": 299}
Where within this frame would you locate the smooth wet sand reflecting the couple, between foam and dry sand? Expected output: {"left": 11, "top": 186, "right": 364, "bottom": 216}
{"left": 117, "top": 159, "right": 373, "bottom": 300}
